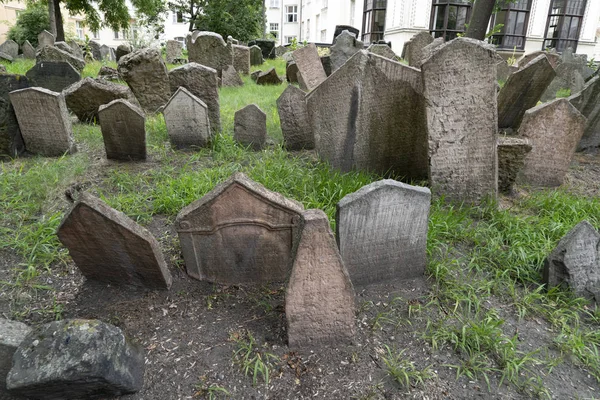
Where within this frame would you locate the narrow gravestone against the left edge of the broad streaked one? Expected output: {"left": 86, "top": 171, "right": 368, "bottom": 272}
{"left": 277, "top": 85, "right": 315, "bottom": 151}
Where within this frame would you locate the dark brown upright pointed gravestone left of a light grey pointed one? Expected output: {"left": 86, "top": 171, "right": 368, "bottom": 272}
{"left": 98, "top": 99, "right": 146, "bottom": 161}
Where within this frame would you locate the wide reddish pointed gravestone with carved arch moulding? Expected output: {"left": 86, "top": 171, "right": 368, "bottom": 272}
{"left": 176, "top": 173, "right": 303, "bottom": 285}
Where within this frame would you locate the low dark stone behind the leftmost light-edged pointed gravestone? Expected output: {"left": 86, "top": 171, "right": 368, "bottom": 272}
{"left": 25, "top": 61, "right": 81, "bottom": 92}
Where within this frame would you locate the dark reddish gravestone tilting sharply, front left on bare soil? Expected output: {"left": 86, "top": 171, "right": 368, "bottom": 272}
{"left": 56, "top": 193, "right": 171, "bottom": 289}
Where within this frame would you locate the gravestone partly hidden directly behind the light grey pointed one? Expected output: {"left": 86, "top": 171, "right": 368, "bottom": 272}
{"left": 169, "top": 63, "right": 221, "bottom": 135}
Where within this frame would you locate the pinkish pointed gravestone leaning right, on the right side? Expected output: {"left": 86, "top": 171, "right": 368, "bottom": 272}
{"left": 518, "top": 98, "right": 587, "bottom": 186}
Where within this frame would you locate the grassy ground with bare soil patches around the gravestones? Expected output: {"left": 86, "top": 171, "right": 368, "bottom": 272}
{"left": 0, "top": 60, "right": 600, "bottom": 400}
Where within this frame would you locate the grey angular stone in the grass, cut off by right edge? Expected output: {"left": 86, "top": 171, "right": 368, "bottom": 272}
{"left": 542, "top": 221, "right": 600, "bottom": 303}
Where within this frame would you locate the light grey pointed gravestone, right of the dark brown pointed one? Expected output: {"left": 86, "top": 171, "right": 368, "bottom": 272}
{"left": 163, "top": 87, "right": 211, "bottom": 149}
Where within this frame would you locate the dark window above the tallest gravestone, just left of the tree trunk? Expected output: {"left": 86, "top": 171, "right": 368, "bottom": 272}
{"left": 429, "top": 0, "right": 471, "bottom": 41}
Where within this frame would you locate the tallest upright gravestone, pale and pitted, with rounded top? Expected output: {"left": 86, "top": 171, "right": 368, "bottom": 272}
{"left": 421, "top": 38, "right": 498, "bottom": 203}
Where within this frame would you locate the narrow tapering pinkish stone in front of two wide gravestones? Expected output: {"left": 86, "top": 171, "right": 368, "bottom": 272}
{"left": 285, "top": 210, "right": 356, "bottom": 348}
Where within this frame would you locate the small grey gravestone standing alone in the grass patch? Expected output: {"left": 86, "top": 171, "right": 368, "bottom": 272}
{"left": 233, "top": 104, "right": 267, "bottom": 150}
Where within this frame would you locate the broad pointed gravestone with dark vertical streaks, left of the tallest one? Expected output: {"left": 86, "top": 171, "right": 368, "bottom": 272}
{"left": 306, "top": 50, "right": 428, "bottom": 179}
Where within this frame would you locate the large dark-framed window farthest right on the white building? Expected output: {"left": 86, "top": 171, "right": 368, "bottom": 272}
{"left": 543, "top": 0, "right": 586, "bottom": 52}
